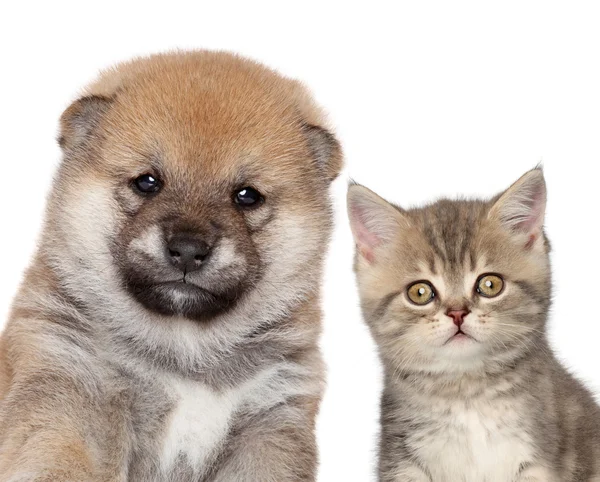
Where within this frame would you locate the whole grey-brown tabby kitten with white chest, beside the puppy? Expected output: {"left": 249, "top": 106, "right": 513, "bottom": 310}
{"left": 348, "top": 169, "right": 600, "bottom": 482}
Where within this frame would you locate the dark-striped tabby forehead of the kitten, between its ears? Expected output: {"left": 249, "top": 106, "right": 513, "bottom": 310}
{"left": 407, "top": 199, "right": 489, "bottom": 276}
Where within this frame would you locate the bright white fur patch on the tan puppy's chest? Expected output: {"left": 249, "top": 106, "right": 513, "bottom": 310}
{"left": 160, "top": 363, "right": 299, "bottom": 474}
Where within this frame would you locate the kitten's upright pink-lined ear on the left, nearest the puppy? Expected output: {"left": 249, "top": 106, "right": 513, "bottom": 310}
{"left": 348, "top": 184, "right": 407, "bottom": 263}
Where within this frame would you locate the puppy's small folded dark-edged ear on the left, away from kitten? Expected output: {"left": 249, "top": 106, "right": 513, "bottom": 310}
{"left": 58, "top": 95, "right": 112, "bottom": 151}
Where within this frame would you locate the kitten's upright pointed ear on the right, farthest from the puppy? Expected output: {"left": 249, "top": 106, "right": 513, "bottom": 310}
{"left": 489, "top": 167, "right": 546, "bottom": 248}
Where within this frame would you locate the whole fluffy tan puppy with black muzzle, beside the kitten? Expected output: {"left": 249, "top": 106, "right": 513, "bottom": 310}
{"left": 0, "top": 52, "right": 342, "bottom": 482}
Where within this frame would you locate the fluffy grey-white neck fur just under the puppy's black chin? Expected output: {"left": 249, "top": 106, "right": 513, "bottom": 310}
{"left": 110, "top": 294, "right": 320, "bottom": 388}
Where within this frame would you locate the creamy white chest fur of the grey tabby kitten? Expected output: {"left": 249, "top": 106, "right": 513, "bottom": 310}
{"left": 409, "top": 399, "right": 534, "bottom": 482}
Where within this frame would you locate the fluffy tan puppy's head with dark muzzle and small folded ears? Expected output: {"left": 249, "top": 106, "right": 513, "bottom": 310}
{"left": 50, "top": 52, "right": 341, "bottom": 320}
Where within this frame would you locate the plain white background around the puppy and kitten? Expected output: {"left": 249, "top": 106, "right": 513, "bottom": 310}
{"left": 0, "top": 1, "right": 600, "bottom": 482}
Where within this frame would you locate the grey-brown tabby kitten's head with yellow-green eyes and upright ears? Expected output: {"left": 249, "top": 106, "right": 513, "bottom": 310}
{"left": 348, "top": 169, "right": 550, "bottom": 372}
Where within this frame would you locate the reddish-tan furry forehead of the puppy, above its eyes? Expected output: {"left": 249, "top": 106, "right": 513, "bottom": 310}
{"left": 89, "top": 53, "right": 319, "bottom": 179}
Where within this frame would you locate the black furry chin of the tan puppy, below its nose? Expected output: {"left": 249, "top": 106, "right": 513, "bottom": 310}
{"left": 127, "top": 281, "right": 241, "bottom": 322}
